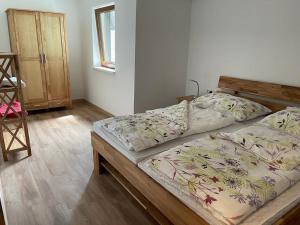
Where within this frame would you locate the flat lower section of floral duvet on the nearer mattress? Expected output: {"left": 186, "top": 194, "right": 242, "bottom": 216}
{"left": 139, "top": 134, "right": 300, "bottom": 225}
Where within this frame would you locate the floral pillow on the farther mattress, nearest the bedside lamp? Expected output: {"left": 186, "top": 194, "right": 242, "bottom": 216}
{"left": 193, "top": 93, "right": 272, "bottom": 121}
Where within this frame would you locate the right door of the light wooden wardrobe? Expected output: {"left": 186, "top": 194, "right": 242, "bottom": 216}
{"left": 40, "top": 13, "right": 70, "bottom": 107}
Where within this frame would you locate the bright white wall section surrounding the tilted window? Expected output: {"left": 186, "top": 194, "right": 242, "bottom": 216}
{"left": 80, "top": 0, "right": 136, "bottom": 115}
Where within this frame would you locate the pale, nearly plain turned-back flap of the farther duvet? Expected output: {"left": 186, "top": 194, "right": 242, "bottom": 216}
{"left": 183, "top": 102, "right": 235, "bottom": 136}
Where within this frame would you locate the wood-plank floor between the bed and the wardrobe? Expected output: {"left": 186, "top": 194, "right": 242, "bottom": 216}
{"left": 0, "top": 103, "right": 155, "bottom": 225}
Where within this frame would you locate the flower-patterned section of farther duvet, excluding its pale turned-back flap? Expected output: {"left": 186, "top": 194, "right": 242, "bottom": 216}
{"left": 100, "top": 101, "right": 188, "bottom": 151}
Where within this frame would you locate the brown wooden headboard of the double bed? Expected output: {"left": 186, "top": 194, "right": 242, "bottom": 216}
{"left": 218, "top": 76, "right": 300, "bottom": 112}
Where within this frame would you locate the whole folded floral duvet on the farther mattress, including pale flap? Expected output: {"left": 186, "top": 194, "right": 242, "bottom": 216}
{"left": 97, "top": 101, "right": 234, "bottom": 152}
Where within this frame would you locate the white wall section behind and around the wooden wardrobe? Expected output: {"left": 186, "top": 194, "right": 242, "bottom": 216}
{"left": 0, "top": 0, "right": 84, "bottom": 99}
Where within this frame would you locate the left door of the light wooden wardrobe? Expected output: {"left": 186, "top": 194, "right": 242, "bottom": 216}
{"left": 8, "top": 10, "right": 48, "bottom": 109}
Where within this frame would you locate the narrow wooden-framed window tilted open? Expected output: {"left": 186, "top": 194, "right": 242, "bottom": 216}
{"left": 95, "top": 5, "right": 116, "bottom": 69}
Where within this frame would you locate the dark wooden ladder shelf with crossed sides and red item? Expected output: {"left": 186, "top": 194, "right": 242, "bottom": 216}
{"left": 0, "top": 53, "right": 31, "bottom": 161}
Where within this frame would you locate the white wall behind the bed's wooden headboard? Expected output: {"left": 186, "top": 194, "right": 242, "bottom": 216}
{"left": 186, "top": 0, "right": 300, "bottom": 94}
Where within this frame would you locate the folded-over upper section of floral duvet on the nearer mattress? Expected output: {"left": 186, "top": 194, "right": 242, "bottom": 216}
{"left": 215, "top": 126, "right": 300, "bottom": 170}
